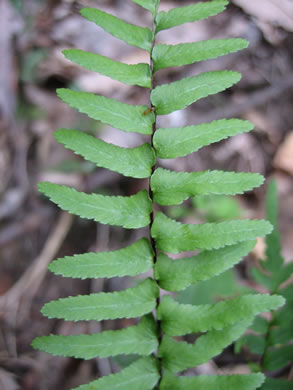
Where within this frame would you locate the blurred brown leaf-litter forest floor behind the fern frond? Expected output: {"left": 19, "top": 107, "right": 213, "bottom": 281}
{"left": 0, "top": 0, "right": 293, "bottom": 390}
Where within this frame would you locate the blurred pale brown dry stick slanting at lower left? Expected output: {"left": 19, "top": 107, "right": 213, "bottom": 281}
{"left": 0, "top": 212, "right": 73, "bottom": 312}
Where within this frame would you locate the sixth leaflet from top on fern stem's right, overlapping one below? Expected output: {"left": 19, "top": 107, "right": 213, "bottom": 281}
{"left": 151, "top": 213, "right": 272, "bottom": 253}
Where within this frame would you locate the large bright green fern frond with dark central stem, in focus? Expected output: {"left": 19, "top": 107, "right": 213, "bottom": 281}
{"left": 33, "top": 0, "right": 284, "bottom": 390}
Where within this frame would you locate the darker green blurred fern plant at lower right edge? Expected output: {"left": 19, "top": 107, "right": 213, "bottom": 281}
{"left": 236, "top": 181, "right": 293, "bottom": 390}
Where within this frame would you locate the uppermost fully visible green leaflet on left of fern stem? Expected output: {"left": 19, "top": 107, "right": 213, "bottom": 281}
{"left": 80, "top": 8, "right": 153, "bottom": 52}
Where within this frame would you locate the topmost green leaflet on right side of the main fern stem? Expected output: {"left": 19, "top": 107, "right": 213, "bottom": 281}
{"left": 156, "top": 0, "right": 228, "bottom": 32}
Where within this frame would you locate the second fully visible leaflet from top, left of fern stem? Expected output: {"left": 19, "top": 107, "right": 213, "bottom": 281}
{"left": 63, "top": 49, "right": 151, "bottom": 88}
